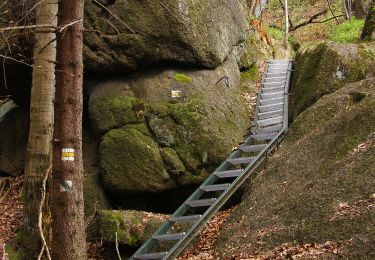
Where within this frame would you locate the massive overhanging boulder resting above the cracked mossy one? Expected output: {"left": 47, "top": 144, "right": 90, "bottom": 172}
{"left": 84, "top": 0, "right": 248, "bottom": 73}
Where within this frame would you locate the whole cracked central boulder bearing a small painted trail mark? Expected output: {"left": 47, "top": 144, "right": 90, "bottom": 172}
{"left": 89, "top": 57, "right": 249, "bottom": 194}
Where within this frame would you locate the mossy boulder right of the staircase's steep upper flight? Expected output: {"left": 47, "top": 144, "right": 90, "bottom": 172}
{"left": 291, "top": 42, "right": 375, "bottom": 119}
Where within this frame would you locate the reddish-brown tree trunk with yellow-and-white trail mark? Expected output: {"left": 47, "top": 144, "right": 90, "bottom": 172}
{"left": 52, "top": 0, "right": 86, "bottom": 260}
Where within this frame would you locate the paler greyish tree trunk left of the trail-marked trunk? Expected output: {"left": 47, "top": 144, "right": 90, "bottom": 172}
{"left": 23, "top": 0, "right": 58, "bottom": 258}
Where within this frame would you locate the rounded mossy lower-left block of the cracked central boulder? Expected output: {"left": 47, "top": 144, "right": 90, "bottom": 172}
{"left": 99, "top": 126, "right": 175, "bottom": 194}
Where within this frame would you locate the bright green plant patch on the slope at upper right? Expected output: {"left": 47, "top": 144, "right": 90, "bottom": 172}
{"left": 329, "top": 17, "right": 364, "bottom": 43}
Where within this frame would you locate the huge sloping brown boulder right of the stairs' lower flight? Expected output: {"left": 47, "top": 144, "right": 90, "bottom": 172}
{"left": 216, "top": 78, "right": 375, "bottom": 259}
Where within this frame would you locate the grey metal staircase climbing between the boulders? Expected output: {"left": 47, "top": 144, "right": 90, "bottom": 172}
{"left": 130, "top": 60, "right": 292, "bottom": 259}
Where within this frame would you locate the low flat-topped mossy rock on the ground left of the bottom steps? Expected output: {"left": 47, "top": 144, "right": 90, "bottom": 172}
{"left": 98, "top": 210, "right": 168, "bottom": 246}
